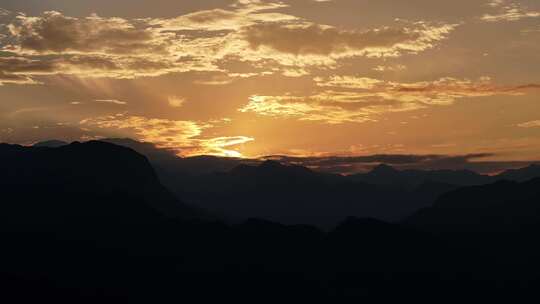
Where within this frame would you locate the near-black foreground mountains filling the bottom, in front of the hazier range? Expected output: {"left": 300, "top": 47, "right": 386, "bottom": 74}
{"left": 0, "top": 141, "right": 540, "bottom": 303}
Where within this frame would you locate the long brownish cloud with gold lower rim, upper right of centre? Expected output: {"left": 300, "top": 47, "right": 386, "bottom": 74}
{"left": 244, "top": 22, "right": 456, "bottom": 57}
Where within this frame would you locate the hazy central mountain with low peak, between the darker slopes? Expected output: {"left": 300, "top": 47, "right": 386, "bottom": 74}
{"left": 175, "top": 161, "right": 446, "bottom": 229}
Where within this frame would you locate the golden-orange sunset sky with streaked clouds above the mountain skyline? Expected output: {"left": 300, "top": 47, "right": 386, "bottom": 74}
{"left": 0, "top": 0, "right": 540, "bottom": 171}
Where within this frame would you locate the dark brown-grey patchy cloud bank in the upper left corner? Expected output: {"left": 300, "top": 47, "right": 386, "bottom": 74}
{"left": 0, "top": 11, "right": 217, "bottom": 79}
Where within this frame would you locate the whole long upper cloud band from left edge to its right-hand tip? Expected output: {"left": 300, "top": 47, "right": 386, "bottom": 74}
{"left": 0, "top": 1, "right": 456, "bottom": 84}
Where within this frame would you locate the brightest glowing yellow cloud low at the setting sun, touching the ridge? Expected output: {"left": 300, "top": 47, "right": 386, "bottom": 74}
{"left": 80, "top": 113, "right": 254, "bottom": 157}
